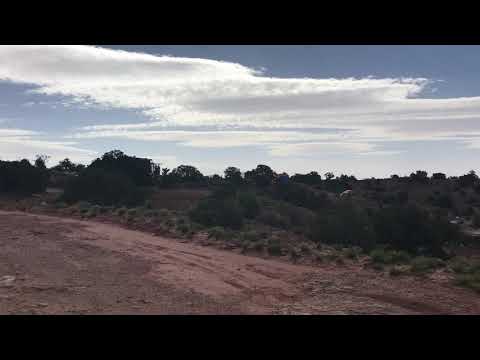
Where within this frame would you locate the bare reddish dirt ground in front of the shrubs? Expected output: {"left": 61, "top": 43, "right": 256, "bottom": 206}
{"left": 0, "top": 211, "right": 480, "bottom": 314}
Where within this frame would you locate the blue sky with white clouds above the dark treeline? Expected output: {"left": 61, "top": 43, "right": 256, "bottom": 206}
{"left": 0, "top": 45, "right": 480, "bottom": 178}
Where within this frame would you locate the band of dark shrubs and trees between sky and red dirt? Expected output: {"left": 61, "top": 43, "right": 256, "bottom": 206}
{"left": 0, "top": 150, "right": 480, "bottom": 289}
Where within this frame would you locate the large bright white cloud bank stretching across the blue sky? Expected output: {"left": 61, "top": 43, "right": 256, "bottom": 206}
{"left": 0, "top": 45, "right": 480, "bottom": 161}
